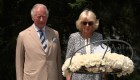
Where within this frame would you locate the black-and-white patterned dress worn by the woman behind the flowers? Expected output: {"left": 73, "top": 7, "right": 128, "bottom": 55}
{"left": 66, "top": 32, "right": 103, "bottom": 80}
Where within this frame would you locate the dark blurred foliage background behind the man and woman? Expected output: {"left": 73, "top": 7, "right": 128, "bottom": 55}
{"left": 0, "top": 0, "right": 140, "bottom": 80}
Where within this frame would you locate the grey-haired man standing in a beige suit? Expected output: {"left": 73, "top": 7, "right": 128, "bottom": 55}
{"left": 16, "top": 4, "right": 62, "bottom": 80}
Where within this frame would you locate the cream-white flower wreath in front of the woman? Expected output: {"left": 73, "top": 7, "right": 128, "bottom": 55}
{"left": 62, "top": 52, "right": 134, "bottom": 77}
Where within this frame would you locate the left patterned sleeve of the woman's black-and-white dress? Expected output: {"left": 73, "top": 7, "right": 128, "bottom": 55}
{"left": 66, "top": 35, "right": 75, "bottom": 59}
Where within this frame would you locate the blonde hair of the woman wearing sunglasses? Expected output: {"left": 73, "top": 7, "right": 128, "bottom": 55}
{"left": 76, "top": 9, "right": 99, "bottom": 31}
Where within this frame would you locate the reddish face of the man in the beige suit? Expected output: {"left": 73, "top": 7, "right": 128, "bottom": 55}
{"left": 32, "top": 7, "right": 48, "bottom": 29}
